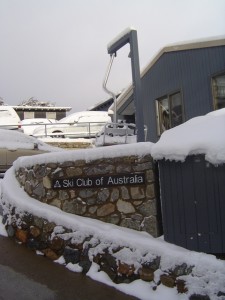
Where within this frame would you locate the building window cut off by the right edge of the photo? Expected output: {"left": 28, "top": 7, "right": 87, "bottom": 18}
{"left": 212, "top": 74, "right": 225, "bottom": 109}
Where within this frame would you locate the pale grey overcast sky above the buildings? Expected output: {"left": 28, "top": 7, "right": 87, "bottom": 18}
{"left": 0, "top": 0, "right": 225, "bottom": 112}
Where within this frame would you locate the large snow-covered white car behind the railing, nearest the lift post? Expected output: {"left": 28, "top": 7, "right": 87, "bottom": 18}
{"left": 33, "top": 111, "right": 111, "bottom": 138}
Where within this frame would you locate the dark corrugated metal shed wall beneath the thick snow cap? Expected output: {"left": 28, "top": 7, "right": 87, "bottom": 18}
{"left": 159, "top": 155, "right": 225, "bottom": 253}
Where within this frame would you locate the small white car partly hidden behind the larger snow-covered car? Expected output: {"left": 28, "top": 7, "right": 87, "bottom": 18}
{"left": 20, "top": 118, "right": 57, "bottom": 135}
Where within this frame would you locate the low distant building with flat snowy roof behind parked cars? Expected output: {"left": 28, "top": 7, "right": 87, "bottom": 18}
{"left": 13, "top": 106, "right": 72, "bottom": 120}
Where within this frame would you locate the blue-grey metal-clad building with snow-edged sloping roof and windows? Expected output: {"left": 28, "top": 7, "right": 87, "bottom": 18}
{"left": 111, "top": 37, "right": 225, "bottom": 142}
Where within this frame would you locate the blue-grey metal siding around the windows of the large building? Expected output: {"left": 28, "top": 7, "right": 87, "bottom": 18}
{"left": 142, "top": 46, "right": 225, "bottom": 142}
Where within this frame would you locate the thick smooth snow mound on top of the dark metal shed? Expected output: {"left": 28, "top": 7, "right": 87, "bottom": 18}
{"left": 151, "top": 109, "right": 225, "bottom": 165}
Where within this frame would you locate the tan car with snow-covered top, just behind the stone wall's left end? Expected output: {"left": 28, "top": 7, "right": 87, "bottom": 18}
{"left": 0, "top": 129, "right": 61, "bottom": 177}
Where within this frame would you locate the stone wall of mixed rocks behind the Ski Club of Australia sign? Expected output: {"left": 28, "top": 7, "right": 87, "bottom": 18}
{"left": 16, "top": 155, "right": 160, "bottom": 237}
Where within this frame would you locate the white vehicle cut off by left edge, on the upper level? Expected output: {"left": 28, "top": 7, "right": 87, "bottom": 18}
{"left": 0, "top": 105, "right": 20, "bottom": 129}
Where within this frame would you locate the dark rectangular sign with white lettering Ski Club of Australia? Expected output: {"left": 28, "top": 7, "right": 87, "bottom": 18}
{"left": 52, "top": 173, "right": 145, "bottom": 189}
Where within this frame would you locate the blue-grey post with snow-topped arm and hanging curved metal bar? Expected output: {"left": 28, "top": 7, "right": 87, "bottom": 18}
{"left": 104, "top": 27, "right": 145, "bottom": 142}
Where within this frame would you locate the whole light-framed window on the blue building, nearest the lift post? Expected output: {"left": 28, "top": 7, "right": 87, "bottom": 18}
{"left": 156, "top": 92, "right": 184, "bottom": 135}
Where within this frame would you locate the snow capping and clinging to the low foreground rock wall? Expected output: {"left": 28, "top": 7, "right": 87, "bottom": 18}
{"left": 1, "top": 167, "right": 225, "bottom": 300}
